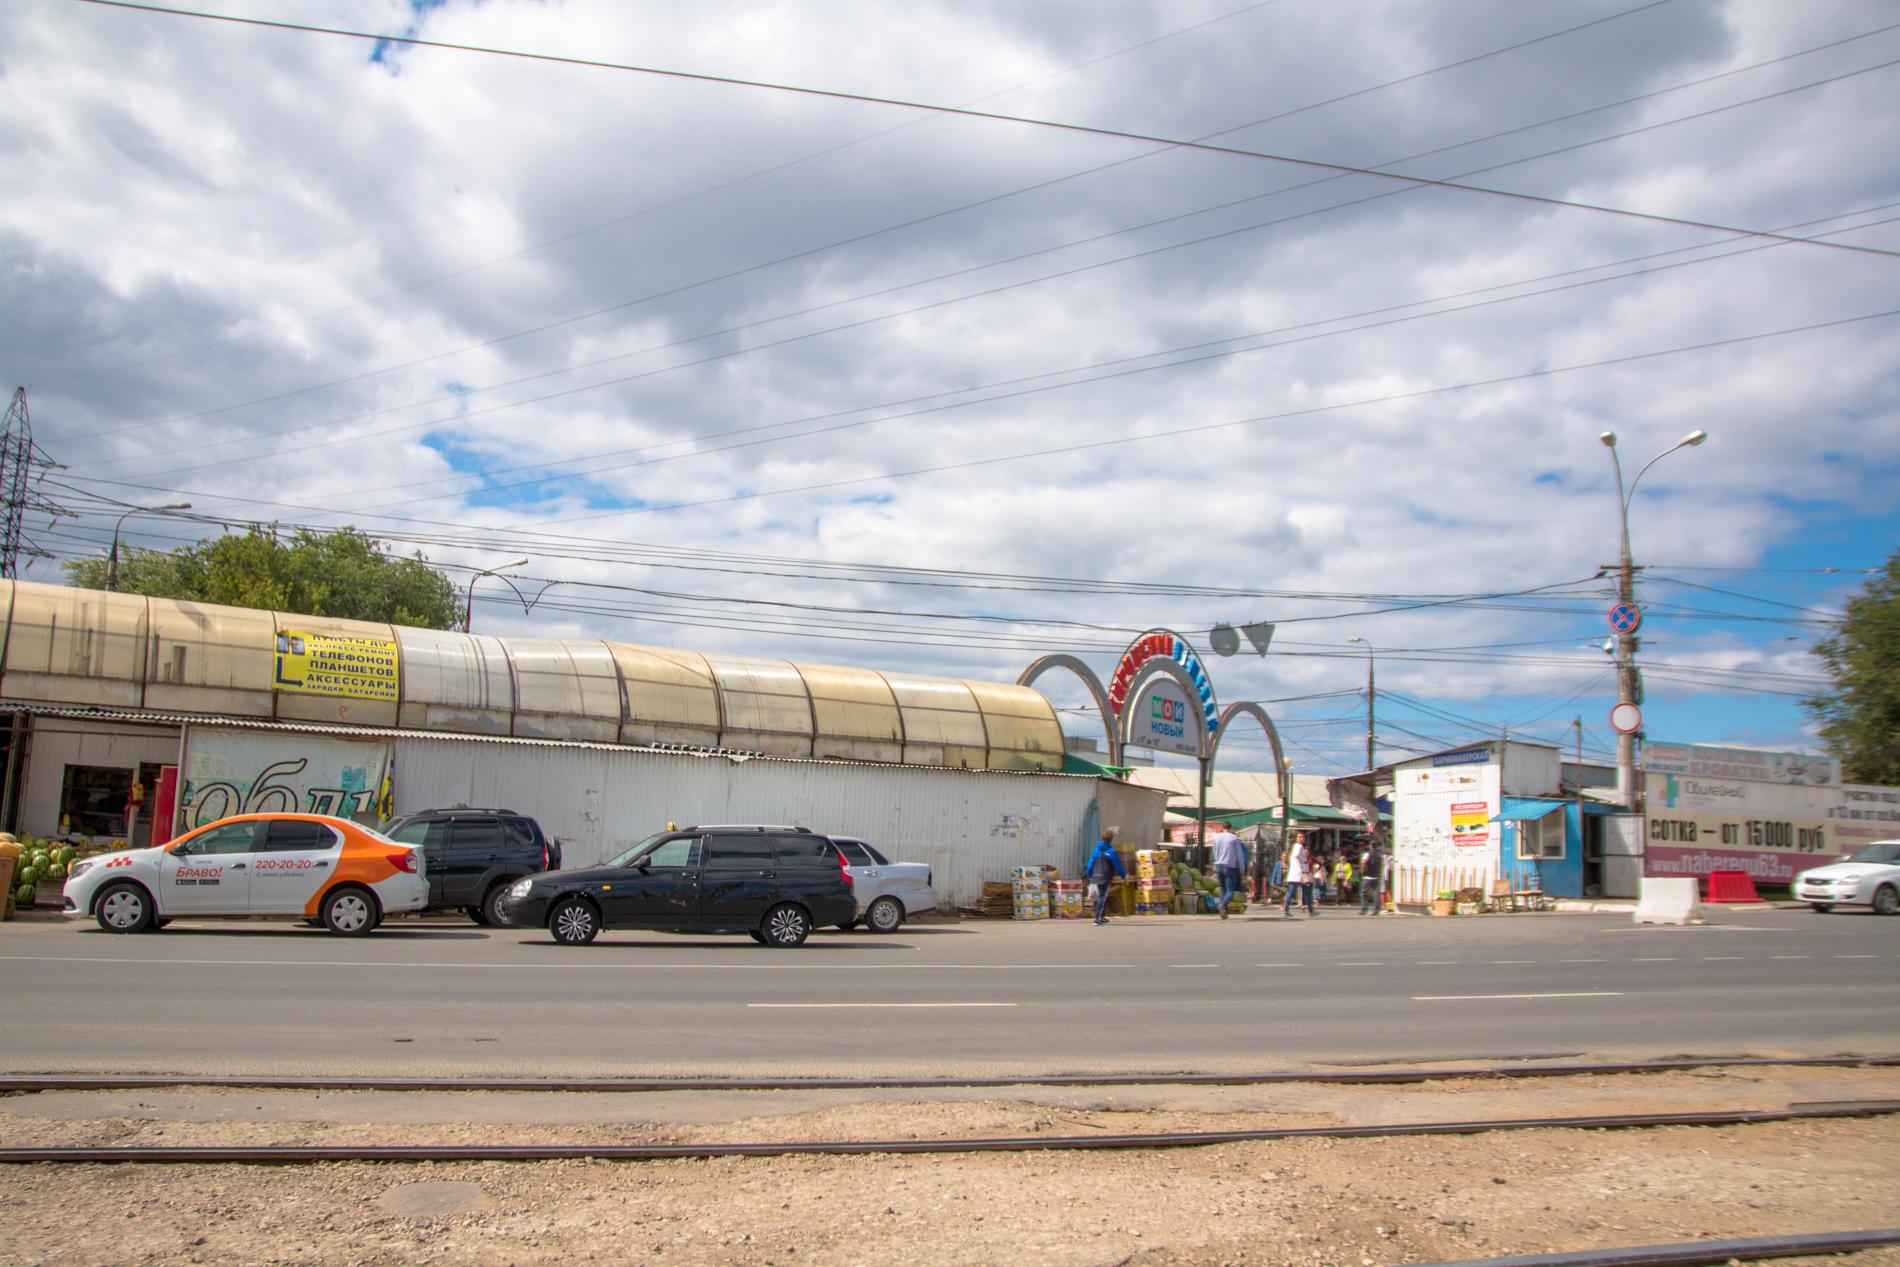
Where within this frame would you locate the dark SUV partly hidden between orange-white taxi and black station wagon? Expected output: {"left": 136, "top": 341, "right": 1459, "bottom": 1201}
{"left": 384, "top": 805, "right": 561, "bottom": 923}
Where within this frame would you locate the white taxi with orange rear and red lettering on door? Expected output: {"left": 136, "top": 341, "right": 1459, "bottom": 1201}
{"left": 65, "top": 813, "right": 429, "bottom": 936}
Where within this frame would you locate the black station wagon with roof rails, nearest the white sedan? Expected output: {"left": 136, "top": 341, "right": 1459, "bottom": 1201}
{"left": 496, "top": 824, "right": 857, "bottom": 946}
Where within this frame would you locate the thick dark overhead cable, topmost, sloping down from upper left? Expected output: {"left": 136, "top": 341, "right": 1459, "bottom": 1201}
{"left": 78, "top": 0, "right": 1900, "bottom": 258}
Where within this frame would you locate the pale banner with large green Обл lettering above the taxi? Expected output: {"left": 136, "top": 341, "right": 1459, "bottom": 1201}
{"left": 181, "top": 726, "right": 391, "bottom": 830}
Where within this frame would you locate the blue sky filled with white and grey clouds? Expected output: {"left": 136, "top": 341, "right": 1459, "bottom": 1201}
{"left": 0, "top": 0, "right": 1900, "bottom": 773}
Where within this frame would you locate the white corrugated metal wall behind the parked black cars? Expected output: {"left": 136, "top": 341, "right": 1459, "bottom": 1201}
{"left": 395, "top": 737, "right": 1117, "bottom": 904}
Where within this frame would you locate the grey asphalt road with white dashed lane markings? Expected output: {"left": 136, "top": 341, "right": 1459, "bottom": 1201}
{"left": 0, "top": 910, "right": 1900, "bottom": 1075}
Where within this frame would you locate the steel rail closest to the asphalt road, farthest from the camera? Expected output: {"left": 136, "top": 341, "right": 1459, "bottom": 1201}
{"left": 0, "top": 1056, "right": 1900, "bottom": 1094}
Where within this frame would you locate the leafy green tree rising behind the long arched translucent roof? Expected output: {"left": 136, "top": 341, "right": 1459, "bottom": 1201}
{"left": 63, "top": 528, "right": 460, "bottom": 629}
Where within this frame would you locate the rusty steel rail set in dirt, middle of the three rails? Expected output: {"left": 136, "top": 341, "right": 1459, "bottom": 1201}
{"left": 0, "top": 1100, "right": 1900, "bottom": 1166}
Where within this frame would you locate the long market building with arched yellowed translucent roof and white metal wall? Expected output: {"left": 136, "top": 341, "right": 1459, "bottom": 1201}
{"left": 0, "top": 581, "right": 1165, "bottom": 904}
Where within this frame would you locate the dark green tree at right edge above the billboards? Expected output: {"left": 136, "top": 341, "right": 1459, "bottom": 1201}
{"left": 1801, "top": 549, "right": 1900, "bottom": 785}
